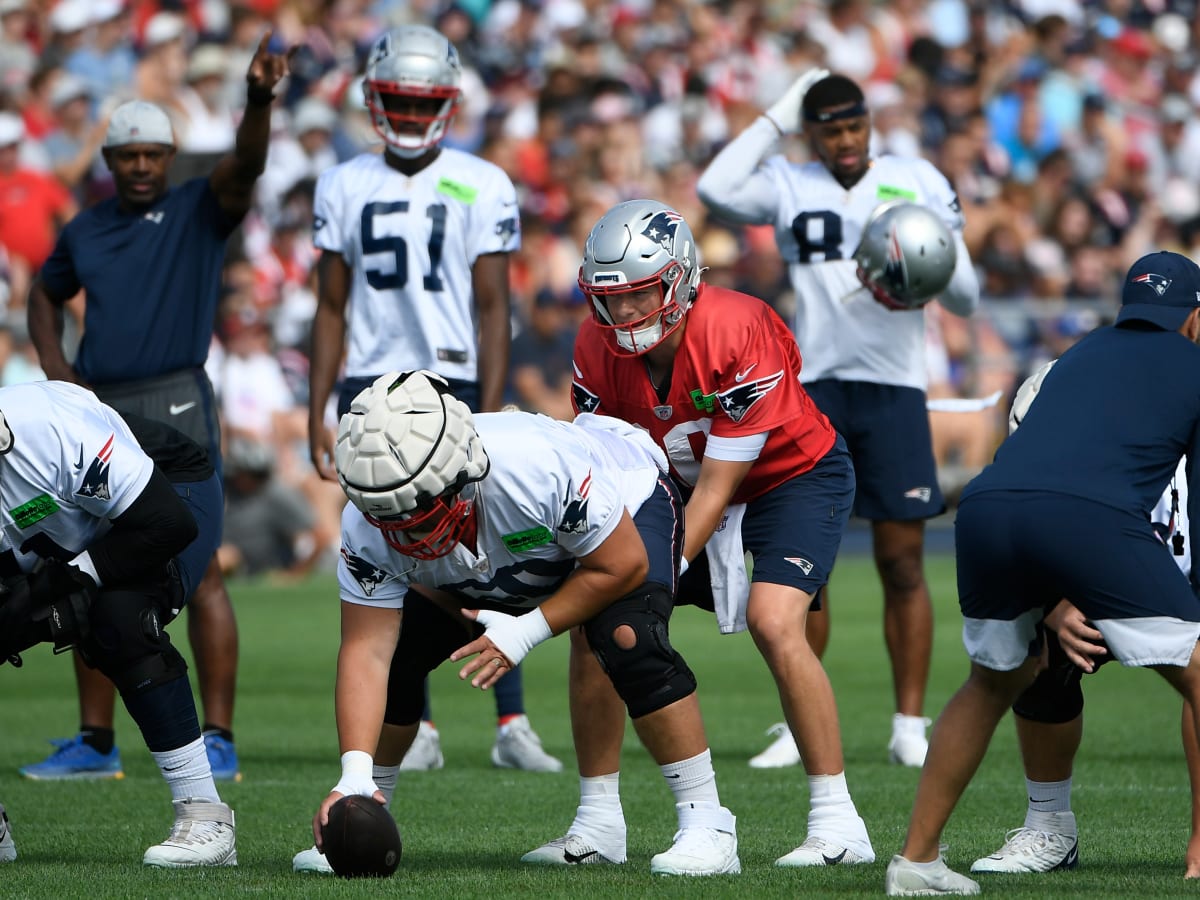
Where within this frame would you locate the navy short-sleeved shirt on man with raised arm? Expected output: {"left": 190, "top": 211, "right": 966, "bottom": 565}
{"left": 41, "top": 178, "right": 238, "bottom": 384}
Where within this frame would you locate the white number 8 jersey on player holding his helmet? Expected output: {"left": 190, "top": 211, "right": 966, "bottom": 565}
{"left": 762, "top": 156, "right": 962, "bottom": 390}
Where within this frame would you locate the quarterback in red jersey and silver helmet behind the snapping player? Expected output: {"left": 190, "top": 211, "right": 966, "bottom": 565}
{"left": 524, "top": 200, "right": 875, "bottom": 866}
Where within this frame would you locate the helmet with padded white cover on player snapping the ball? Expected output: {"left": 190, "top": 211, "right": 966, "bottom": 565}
{"left": 334, "top": 370, "right": 488, "bottom": 559}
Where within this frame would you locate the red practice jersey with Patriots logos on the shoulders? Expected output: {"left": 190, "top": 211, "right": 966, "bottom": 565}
{"left": 571, "top": 284, "right": 838, "bottom": 503}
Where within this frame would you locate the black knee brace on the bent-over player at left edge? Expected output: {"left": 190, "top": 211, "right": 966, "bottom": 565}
{"left": 79, "top": 586, "right": 187, "bottom": 696}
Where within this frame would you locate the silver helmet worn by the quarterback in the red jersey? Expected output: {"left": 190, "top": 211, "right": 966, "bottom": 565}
{"left": 580, "top": 200, "right": 702, "bottom": 355}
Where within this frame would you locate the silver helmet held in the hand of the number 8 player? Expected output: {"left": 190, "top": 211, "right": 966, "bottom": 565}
{"left": 854, "top": 200, "right": 958, "bottom": 310}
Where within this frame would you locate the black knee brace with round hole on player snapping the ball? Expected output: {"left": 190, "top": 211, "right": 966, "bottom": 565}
{"left": 583, "top": 583, "right": 696, "bottom": 719}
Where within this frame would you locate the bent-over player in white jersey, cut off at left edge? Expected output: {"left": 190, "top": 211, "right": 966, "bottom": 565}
{"left": 0, "top": 382, "right": 231, "bottom": 868}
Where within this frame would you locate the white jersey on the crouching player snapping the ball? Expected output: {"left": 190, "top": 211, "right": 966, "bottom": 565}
{"left": 337, "top": 413, "right": 666, "bottom": 610}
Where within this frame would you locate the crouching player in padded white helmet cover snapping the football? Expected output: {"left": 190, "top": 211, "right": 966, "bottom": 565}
{"left": 313, "top": 371, "right": 740, "bottom": 875}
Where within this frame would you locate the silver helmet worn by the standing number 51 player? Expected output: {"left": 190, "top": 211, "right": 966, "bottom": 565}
{"left": 362, "top": 25, "right": 462, "bottom": 158}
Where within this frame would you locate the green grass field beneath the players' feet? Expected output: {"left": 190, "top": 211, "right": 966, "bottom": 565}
{"left": 0, "top": 557, "right": 1196, "bottom": 899}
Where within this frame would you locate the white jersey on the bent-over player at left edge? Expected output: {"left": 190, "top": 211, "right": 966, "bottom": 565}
{"left": 0, "top": 382, "right": 154, "bottom": 571}
